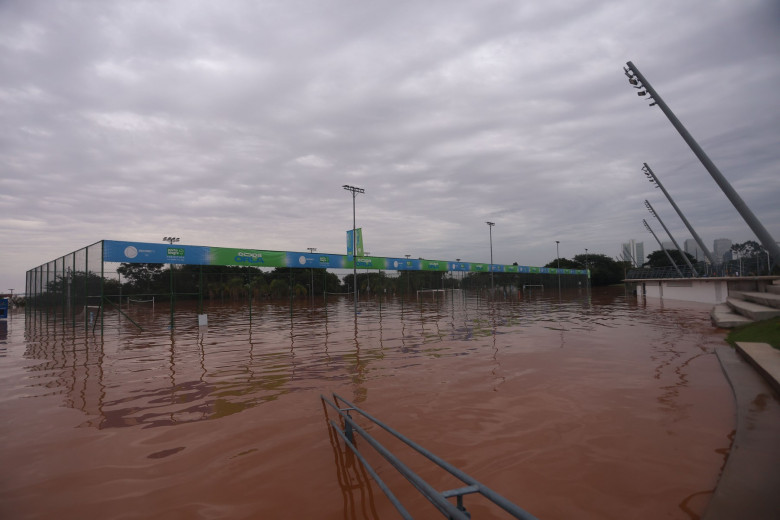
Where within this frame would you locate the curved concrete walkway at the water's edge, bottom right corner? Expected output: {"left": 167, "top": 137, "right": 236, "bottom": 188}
{"left": 702, "top": 343, "right": 780, "bottom": 520}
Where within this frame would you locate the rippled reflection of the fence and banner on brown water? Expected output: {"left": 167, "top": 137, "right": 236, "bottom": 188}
{"left": 25, "top": 292, "right": 603, "bottom": 429}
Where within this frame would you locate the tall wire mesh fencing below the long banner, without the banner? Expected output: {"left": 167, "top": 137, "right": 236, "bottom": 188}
{"left": 26, "top": 241, "right": 588, "bottom": 333}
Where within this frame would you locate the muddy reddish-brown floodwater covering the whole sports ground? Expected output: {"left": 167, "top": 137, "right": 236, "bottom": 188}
{"left": 0, "top": 288, "right": 735, "bottom": 520}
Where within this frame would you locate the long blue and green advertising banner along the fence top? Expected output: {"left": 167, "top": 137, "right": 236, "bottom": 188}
{"left": 103, "top": 240, "right": 587, "bottom": 275}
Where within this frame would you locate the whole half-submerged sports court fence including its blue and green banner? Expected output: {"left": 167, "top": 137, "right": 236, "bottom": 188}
{"left": 26, "top": 240, "right": 588, "bottom": 331}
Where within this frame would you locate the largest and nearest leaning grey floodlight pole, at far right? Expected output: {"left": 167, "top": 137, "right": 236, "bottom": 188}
{"left": 623, "top": 61, "right": 780, "bottom": 264}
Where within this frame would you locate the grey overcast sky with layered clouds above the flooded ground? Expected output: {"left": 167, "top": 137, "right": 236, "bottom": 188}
{"left": 0, "top": 0, "right": 780, "bottom": 292}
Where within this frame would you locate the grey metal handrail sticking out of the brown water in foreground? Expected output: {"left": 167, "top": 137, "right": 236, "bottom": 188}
{"left": 320, "top": 393, "right": 536, "bottom": 520}
